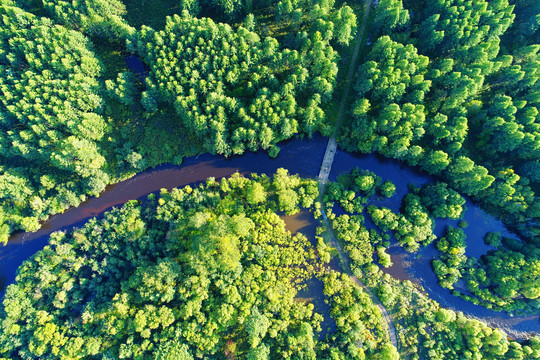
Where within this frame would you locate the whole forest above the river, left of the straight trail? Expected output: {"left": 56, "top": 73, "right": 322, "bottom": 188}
{"left": 0, "top": 0, "right": 356, "bottom": 242}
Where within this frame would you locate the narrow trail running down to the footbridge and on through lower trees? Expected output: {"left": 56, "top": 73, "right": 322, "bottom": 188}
{"left": 319, "top": 0, "right": 399, "bottom": 349}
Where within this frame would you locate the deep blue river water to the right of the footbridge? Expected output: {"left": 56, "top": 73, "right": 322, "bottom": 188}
{"left": 330, "top": 151, "right": 540, "bottom": 338}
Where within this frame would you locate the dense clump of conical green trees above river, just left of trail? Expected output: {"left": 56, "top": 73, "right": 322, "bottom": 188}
{"left": 132, "top": 13, "right": 337, "bottom": 155}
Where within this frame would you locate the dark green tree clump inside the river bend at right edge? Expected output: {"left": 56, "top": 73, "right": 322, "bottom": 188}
{"left": 433, "top": 226, "right": 540, "bottom": 313}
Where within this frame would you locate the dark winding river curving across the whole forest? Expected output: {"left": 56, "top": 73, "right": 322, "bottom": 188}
{"left": 0, "top": 136, "right": 540, "bottom": 338}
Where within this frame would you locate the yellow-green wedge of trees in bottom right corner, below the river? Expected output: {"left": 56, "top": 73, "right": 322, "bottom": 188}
{"left": 379, "top": 276, "right": 540, "bottom": 360}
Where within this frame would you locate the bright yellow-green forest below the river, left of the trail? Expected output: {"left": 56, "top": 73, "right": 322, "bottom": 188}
{"left": 0, "top": 169, "right": 395, "bottom": 359}
